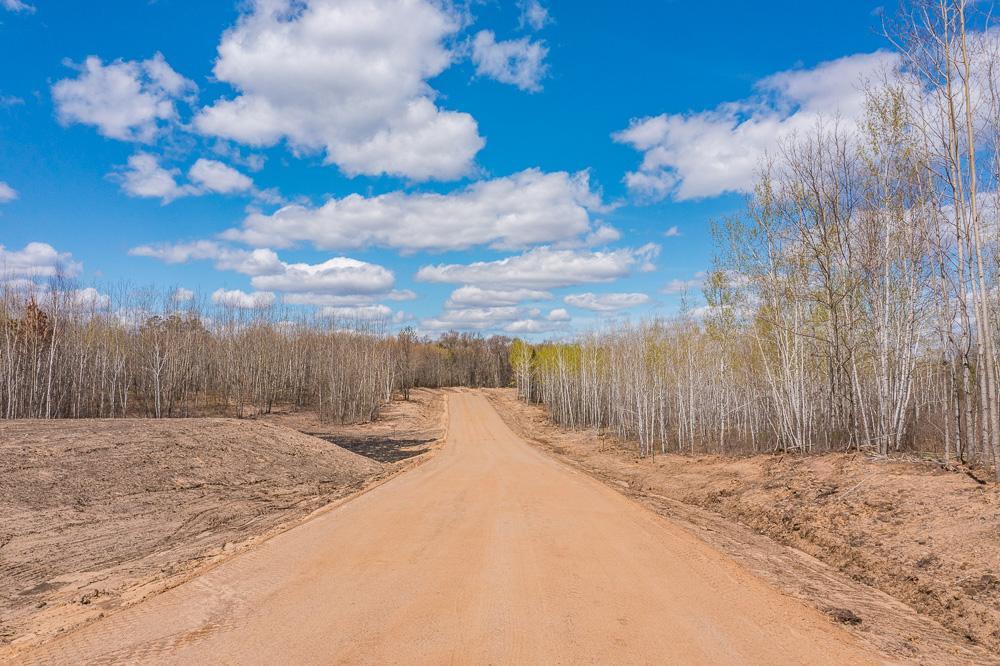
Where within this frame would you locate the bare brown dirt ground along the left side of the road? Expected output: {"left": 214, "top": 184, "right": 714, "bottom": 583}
{"left": 0, "top": 391, "right": 445, "bottom": 660}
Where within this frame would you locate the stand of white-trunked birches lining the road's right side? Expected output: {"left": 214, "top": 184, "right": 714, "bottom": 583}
{"left": 511, "top": 0, "right": 1000, "bottom": 478}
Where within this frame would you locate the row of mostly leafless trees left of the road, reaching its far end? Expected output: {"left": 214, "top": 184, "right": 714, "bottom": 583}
{"left": 0, "top": 279, "right": 510, "bottom": 422}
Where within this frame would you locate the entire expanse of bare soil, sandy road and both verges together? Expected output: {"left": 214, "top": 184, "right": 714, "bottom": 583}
{"left": 9, "top": 390, "right": 1000, "bottom": 664}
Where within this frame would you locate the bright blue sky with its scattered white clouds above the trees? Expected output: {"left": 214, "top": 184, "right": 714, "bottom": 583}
{"left": 0, "top": 0, "right": 891, "bottom": 337}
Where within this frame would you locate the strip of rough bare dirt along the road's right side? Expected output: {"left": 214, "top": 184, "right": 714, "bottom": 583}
{"left": 489, "top": 389, "right": 1000, "bottom": 663}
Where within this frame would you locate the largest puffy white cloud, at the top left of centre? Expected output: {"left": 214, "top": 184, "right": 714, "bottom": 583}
{"left": 195, "top": 0, "right": 484, "bottom": 180}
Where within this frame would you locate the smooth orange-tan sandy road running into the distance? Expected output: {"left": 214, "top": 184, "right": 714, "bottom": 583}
{"left": 13, "top": 392, "right": 878, "bottom": 664}
